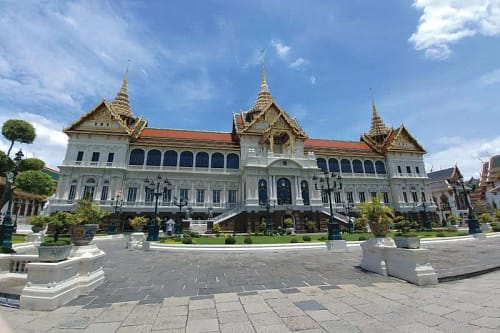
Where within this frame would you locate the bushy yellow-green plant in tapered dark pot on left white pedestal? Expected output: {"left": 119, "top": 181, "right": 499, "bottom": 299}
{"left": 69, "top": 197, "right": 109, "bottom": 246}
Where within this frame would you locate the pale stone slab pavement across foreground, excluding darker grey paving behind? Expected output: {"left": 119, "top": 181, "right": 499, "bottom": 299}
{"left": 0, "top": 272, "right": 500, "bottom": 333}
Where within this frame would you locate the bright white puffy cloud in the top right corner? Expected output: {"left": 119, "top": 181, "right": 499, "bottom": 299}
{"left": 409, "top": 0, "right": 500, "bottom": 60}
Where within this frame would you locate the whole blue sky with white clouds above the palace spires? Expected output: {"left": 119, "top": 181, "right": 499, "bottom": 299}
{"left": 0, "top": 0, "right": 500, "bottom": 176}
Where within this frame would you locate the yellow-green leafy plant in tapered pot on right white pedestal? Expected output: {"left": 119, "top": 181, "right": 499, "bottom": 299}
{"left": 359, "top": 195, "right": 394, "bottom": 237}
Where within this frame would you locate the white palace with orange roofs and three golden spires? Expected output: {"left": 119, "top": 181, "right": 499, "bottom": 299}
{"left": 47, "top": 68, "right": 436, "bottom": 232}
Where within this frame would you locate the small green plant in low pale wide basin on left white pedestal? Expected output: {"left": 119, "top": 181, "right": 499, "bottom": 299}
{"left": 38, "top": 212, "right": 75, "bottom": 262}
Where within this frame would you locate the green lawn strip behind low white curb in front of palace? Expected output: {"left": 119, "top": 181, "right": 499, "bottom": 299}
{"left": 161, "top": 231, "right": 467, "bottom": 245}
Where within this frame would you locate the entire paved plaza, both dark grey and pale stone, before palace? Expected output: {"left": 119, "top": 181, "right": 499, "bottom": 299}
{"left": 0, "top": 237, "right": 500, "bottom": 332}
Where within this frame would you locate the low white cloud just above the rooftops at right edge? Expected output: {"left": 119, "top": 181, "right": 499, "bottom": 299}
{"left": 425, "top": 136, "right": 500, "bottom": 178}
